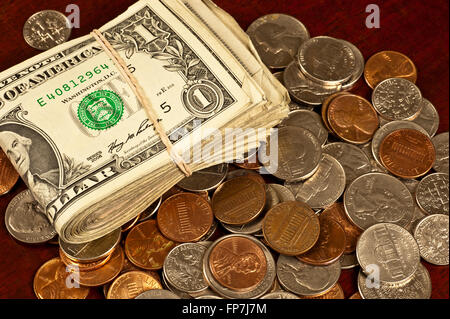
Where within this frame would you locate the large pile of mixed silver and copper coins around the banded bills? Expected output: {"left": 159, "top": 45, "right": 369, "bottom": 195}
{"left": 0, "top": 14, "right": 449, "bottom": 299}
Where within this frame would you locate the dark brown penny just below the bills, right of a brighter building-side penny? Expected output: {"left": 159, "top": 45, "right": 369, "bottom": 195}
{"left": 156, "top": 193, "right": 214, "bottom": 243}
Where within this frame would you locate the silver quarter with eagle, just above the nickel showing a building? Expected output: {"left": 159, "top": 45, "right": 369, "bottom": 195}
{"left": 344, "top": 173, "right": 414, "bottom": 230}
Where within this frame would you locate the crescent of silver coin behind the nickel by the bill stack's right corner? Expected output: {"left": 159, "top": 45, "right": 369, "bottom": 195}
{"left": 278, "top": 110, "right": 328, "bottom": 145}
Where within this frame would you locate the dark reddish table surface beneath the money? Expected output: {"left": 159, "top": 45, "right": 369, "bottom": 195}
{"left": 0, "top": 0, "right": 449, "bottom": 299}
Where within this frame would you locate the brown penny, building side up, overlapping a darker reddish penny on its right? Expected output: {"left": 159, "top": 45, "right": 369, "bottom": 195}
{"left": 262, "top": 201, "right": 320, "bottom": 256}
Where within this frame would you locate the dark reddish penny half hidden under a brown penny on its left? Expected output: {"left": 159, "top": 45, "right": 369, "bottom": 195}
{"left": 297, "top": 216, "right": 345, "bottom": 266}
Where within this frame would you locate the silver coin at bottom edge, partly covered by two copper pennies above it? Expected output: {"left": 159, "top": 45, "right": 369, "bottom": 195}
{"left": 277, "top": 255, "right": 341, "bottom": 296}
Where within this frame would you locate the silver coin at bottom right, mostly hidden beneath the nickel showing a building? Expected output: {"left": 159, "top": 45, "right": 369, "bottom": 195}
{"left": 358, "top": 264, "right": 431, "bottom": 299}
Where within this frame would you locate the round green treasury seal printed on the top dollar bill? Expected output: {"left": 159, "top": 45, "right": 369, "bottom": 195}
{"left": 78, "top": 90, "right": 123, "bottom": 130}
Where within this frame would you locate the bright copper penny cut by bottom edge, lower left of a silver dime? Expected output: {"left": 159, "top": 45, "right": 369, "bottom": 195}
{"left": 106, "top": 271, "right": 163, "bottom": 299}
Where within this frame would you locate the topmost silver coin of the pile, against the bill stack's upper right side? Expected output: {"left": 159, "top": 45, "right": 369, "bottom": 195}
{"left": 247, "top": 13, "right": 309, "bottom": 69}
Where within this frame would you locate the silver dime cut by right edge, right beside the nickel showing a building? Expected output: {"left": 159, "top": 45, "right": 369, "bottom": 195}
{"left": 414, "top": 214, "right": 449, "bottom": 266}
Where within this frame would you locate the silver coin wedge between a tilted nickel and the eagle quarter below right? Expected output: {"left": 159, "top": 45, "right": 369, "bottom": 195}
{"left": 322, "top": 142, "right": 372, "bottom": 185}
